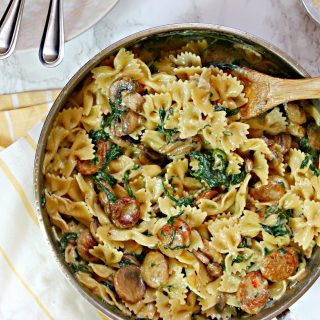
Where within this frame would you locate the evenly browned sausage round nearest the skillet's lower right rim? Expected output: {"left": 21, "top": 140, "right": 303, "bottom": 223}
{"left": 261, "top": 247, "right": 299, "bottom": 281}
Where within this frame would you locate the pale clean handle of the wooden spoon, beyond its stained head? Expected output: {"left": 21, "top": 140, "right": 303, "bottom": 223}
{"left": 269, "top": 77, "right": 320, "bottom": 105}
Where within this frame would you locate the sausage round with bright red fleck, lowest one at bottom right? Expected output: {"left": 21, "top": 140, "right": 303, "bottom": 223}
{"left": 237, "top": 271, "right": 269, "bottom": 314}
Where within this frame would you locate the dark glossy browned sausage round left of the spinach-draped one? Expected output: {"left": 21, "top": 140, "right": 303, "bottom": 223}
{"left": 110, "top": 197, "right": 140, "bottom": 229}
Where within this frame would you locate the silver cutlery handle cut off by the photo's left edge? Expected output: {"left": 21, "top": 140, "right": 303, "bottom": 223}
{"left": 0, "top": 0, "right": 25, "bottom": 59}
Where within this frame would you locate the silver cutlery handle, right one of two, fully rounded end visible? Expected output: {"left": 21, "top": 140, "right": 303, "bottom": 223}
{"left": 39, "top": 0, "right": 64, "bottom": 67}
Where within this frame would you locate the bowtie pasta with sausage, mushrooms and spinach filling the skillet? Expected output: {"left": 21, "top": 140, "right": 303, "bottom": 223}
{"left": 43, "top": 41, "right": 320, "bottom": 320}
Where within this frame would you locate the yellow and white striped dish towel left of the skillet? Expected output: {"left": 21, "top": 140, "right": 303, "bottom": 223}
{"left": 0, "top": 91, "right": 108, "bottom": 320}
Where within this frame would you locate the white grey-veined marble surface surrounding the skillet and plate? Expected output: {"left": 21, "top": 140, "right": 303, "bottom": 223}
{"left": 0, "top": 0, "right": 320, "bottom": 320}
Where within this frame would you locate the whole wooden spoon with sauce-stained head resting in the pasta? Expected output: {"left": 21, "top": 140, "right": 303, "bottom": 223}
{"left": 210, "top": 64, "right": 320, "bottom": 119}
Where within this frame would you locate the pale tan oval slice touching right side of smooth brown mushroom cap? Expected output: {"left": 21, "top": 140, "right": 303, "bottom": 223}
{"left": 141, "top": 251, "right": 169, "bottom": 289}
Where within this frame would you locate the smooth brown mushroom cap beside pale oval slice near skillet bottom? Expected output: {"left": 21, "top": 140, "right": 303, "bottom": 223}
{"left": 114, "top": 265, "right": 146, "bottom": 303}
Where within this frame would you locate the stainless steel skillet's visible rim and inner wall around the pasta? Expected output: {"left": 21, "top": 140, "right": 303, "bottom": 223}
{"left": 34, "top": 24, "right": 320, "bottom": 320}
